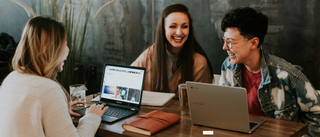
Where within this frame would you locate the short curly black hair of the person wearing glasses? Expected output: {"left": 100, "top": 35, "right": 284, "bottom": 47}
{"left": 221, "top": 7, "right": 268, "bottom": 47}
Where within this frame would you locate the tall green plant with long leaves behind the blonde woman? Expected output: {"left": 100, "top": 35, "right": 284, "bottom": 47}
{"left": 11, "top": 0, "right": 115, "bottom": 89}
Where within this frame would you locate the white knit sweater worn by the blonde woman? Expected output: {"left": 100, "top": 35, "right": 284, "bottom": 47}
{"left": 0, "top": 71, "right": 101, "bottom": 137}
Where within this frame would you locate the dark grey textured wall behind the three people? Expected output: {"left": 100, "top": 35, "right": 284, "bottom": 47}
{"left": 0, "top": 0, "right": 320, "bottom": 92}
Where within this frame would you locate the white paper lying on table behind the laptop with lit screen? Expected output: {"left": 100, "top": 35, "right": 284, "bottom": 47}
{"left": 91, "top": 90, "right": 175, "bottom": 107}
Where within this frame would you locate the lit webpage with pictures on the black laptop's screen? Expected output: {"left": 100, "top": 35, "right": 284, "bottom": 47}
{"left": 101, "top": 66, "right": 143, "bottom": 104}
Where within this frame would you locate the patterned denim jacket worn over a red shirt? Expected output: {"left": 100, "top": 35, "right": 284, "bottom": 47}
{"left": 218, "top": 48, "right": 320, "bottom": 137}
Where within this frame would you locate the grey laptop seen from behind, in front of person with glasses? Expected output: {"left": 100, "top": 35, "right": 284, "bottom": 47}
{"left": 186, "top": 81, "right": 265, "bottom": 133}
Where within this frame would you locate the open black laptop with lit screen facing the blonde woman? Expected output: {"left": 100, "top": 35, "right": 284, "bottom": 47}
{"left": 76, "top": 63, "right": 145, "bottom": 122}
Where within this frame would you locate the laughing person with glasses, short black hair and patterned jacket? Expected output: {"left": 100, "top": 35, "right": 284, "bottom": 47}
{"left": 218, "top": 7, "right": 320, "bottom": 136}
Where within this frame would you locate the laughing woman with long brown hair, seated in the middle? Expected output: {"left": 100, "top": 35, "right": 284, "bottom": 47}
{"left": 131, "top": 4, "right": 213, "bottom": 98}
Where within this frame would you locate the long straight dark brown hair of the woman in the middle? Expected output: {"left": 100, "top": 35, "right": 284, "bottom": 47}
{"left": 151, "top": 4, "right": 213, "bottom": 92}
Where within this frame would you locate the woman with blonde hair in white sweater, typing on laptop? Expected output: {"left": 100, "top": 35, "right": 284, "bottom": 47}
{"left": 0, "top": 16, "right": 107, "bottom": 137}
